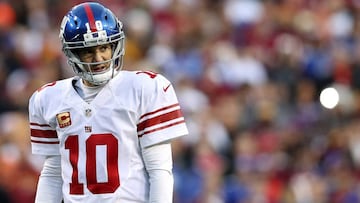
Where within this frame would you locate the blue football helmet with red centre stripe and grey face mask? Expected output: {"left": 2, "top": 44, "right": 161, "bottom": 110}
{"left": 59, "top": 2, "right": 125, "bottom": 85}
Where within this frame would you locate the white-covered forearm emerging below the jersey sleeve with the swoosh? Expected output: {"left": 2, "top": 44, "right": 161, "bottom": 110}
{"left": 142, "top": 142, "right": 174, "bottom": 203}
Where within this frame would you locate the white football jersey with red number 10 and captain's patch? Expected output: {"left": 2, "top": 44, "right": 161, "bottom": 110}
{"left": 29, "top": 71, "right": 188, "bottom": 203}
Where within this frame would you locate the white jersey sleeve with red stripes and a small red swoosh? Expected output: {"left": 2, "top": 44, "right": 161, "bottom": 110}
{"left": 137, "top": 74, "right": 188, "bottom": 147}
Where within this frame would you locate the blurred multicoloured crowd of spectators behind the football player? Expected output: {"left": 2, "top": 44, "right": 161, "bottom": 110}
{"left": 0, "top": 0, "right": 360, "bottom": 203}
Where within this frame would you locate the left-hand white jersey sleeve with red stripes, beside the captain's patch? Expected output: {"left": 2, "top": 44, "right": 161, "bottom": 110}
{"left": 29, "top": 91, "right": 60, "bottom": 155}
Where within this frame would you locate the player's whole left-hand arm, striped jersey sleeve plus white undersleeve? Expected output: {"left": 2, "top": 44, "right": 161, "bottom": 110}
{"left": 29, "top": 83, "right": 62, "bottom": 203}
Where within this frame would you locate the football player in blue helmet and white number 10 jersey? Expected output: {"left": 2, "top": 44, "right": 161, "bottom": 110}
{"left": 29, "top": 2, "right": 188, "bottom": 203}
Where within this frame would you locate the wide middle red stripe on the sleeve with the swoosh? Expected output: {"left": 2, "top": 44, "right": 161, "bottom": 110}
{"left": 137, "top": 109, "right": 182, "bottom": 132}
